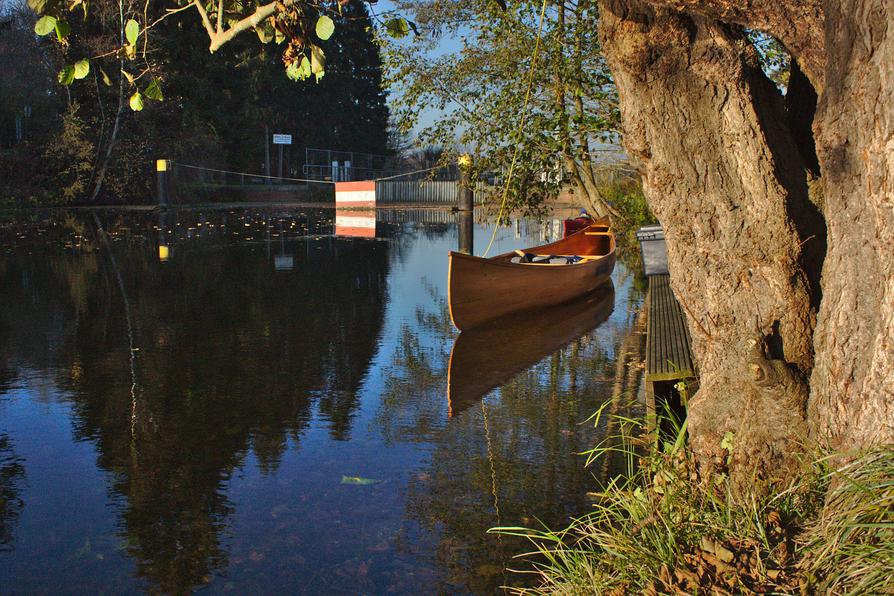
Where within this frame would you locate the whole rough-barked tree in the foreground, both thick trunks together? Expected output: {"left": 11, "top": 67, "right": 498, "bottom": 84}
{"left": 601, "top": 0, "right": 894, "bottom": 480}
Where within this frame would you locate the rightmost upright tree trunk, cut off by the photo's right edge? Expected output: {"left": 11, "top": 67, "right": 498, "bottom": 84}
{"left": 809, "top": 0, "right": 894, "bottom": 450}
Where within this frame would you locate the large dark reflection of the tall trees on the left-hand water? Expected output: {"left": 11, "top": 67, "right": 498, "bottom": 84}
{"left": 0, "top": 212, "right": 388, "bottom": 593}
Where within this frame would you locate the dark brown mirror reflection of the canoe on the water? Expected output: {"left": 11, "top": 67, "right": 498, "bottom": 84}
{"left": 447, "top": 280, "right": 615, "bottom": 416}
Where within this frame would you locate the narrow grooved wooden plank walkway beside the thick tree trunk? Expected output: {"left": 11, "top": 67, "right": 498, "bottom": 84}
{"left": 645, "top": 274, "right": 696, "bottom": 384}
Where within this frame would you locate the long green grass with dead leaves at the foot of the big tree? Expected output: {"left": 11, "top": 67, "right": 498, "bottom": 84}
{"left": 492, "top": 412, "right": 894, "bottom": 594}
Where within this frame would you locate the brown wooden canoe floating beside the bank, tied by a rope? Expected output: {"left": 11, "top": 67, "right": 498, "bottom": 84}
{"left": 447, "top": 220, "right": 615, "bottom": 331}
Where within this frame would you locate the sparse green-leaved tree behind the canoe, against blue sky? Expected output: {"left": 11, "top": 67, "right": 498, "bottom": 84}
{"left": 383, "top": 0, "right": 620, "bottom": 213}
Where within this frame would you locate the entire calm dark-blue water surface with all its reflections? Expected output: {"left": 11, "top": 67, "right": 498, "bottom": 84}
{"left": 0, "top": 209, "right": 640, "bottom": 594}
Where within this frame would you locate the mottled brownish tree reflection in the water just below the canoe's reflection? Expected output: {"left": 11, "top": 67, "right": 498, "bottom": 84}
{"left": 376, "top": 274, "right": 632, "bottom": 593}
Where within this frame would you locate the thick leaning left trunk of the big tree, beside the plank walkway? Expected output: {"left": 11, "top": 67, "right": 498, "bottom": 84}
{"left": 601, "top": 0, "right": 822, "bottom": 481}
